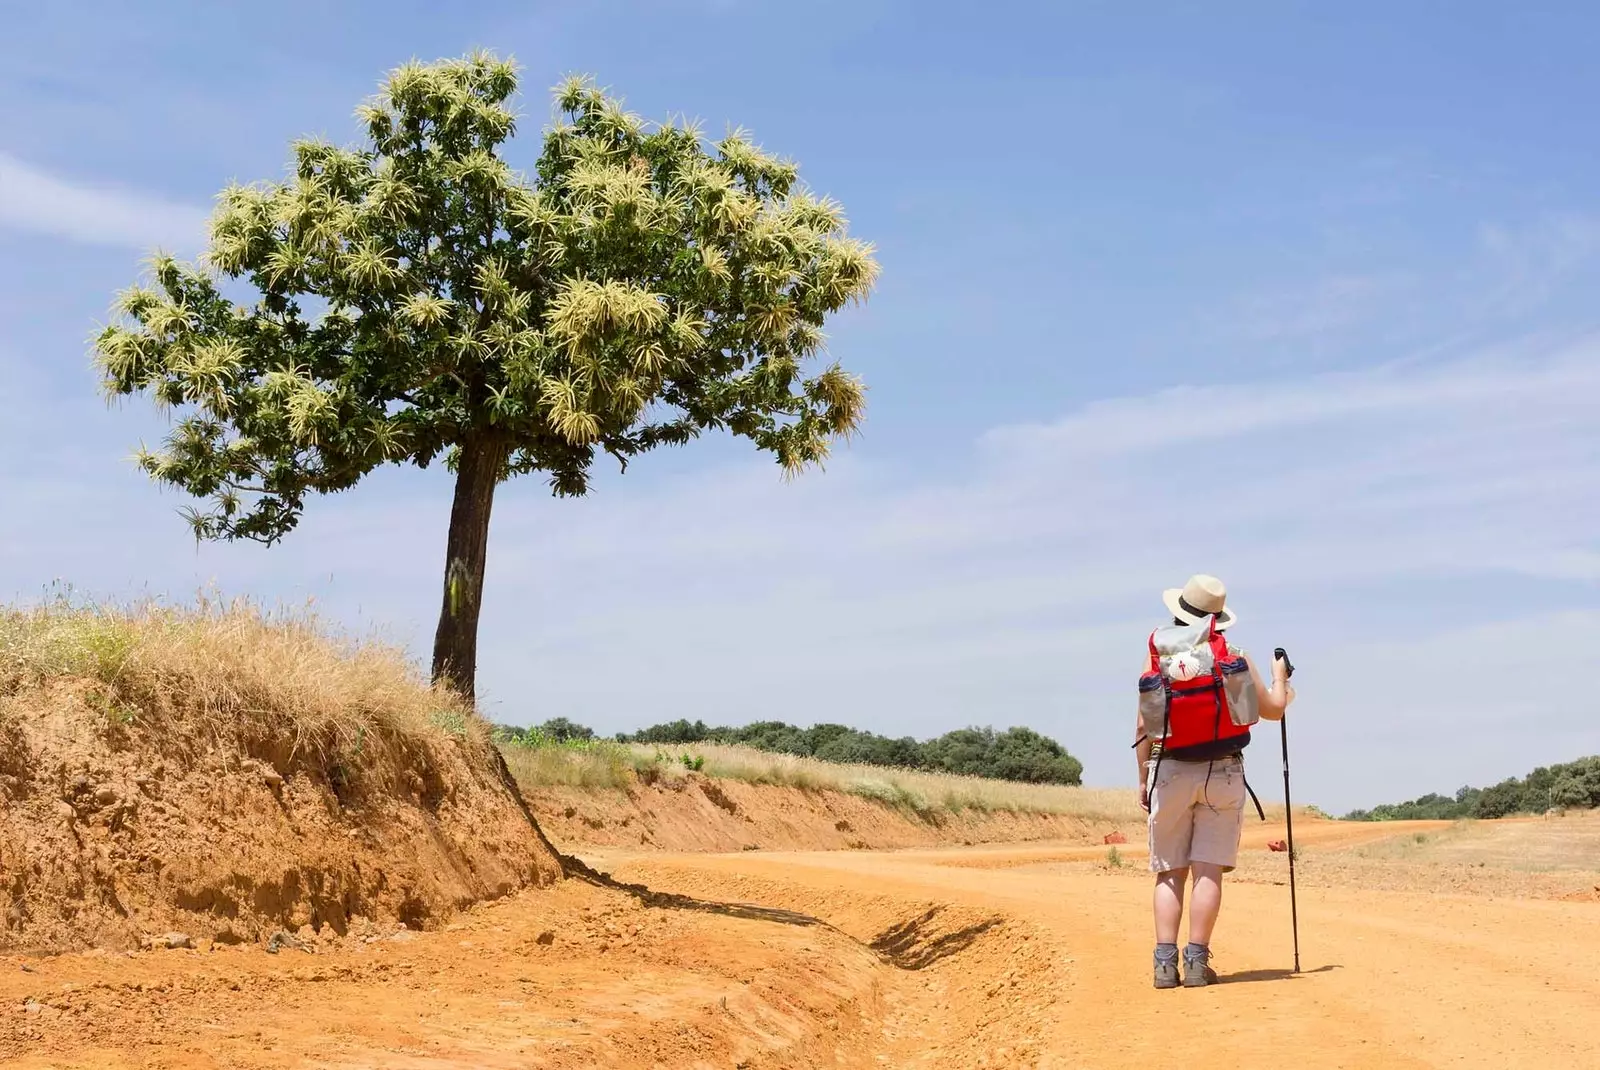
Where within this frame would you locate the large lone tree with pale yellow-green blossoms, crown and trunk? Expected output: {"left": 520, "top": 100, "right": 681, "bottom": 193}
{"left": 96, "top": 54, "right": 877, "bottom": 697}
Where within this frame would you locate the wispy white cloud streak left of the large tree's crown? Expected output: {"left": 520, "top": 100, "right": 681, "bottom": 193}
{"left": 0, "top": 152, "right": 206, "bottom": 251}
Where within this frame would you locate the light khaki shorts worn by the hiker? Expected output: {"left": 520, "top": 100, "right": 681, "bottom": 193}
{"left": 1150, "top": 758, "right": 1245, "bottom": 873}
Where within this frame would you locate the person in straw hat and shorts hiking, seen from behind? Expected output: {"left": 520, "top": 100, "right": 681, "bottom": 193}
{"left": 1134, "top": 576, "right": 1294, "bottom": 988}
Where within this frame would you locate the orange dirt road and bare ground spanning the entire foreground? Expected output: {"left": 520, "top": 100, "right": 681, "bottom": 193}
{"left": 0, "top": 824, "right": 1600, "bottom": 1070}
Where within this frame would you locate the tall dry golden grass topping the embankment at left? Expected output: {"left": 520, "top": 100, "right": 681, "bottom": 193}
{"left": 0, "top": 600, "right": 488, "bottom": 780}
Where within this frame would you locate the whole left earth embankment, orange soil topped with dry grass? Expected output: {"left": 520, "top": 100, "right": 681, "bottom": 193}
{"left": 0, "top": 609, "right": 562, "bottom": 950}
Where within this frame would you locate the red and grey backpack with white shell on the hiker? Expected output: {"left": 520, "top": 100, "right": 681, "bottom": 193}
{"left": 1139, "top": 617, "right": 1261, "bottom": 761}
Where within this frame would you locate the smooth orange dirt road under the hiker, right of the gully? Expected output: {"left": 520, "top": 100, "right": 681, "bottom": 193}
{"left": 601, "top": 812, "right": 1600, "bottom": 1068}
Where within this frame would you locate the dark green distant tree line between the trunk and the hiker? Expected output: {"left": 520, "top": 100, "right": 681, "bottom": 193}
{"left": 496, "top": 717, "right": 1083, "bottom": 785}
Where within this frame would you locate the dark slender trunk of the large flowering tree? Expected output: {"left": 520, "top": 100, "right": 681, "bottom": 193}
{"left": 434, "top": 435, "right": 506, "bottom": 702}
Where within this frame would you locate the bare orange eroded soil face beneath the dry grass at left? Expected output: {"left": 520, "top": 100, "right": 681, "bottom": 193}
{"left": 0, "top": 683, "right": 560, "bottom": 950}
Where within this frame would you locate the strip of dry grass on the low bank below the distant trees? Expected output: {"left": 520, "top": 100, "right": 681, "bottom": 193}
{"left": 501, "top": 742, "right": 1144, "bottom": 822}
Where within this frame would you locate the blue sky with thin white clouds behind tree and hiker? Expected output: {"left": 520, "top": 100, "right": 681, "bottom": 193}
{"left": 0, "top": 0, "right": 1600, "bottom": 809}
